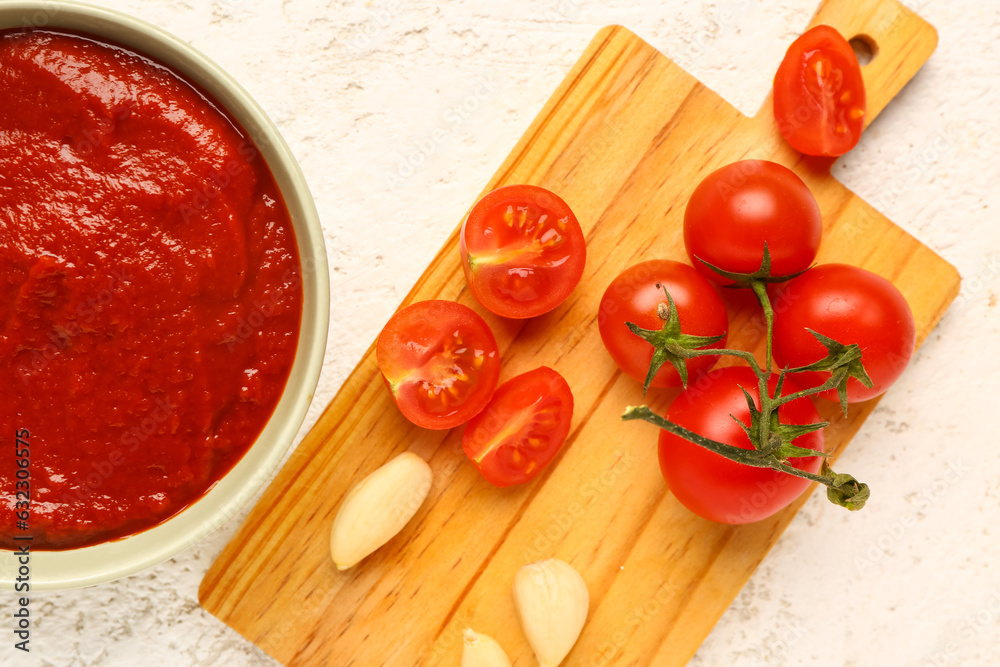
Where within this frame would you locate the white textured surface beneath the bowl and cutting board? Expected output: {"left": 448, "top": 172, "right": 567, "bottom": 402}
{"left": 0, "top": 0, "right": 1000, "bottom": 667}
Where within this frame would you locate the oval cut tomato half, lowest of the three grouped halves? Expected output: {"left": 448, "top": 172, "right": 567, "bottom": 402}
{"left": 462, "top": 366, "right": 573, "bottom": 487}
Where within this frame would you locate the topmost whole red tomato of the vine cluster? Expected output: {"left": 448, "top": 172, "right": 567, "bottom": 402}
{"left": 684, "top": 160, "right": 823, "bottom": 285}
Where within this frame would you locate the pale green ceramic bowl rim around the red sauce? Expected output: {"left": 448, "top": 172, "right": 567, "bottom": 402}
{"left": 0, "top": 2, "right": 330, "bottom": 590}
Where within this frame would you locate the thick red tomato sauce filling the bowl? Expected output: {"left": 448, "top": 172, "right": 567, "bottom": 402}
{"left": 0, "top": 30, "right": 302, "bottom": 549}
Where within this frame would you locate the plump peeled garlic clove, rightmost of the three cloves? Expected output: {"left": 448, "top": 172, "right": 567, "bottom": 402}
{"left": 514, "top": 558, "right": 590, "bottom": 667}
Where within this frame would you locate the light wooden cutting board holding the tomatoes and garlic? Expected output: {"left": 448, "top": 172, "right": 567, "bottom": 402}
{"left": 200, "top": 0, "right": 959, "bottom": 667}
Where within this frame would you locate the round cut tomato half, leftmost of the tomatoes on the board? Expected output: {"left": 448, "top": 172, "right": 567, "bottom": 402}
{"left": 375, "top": 300, "right": 500, "bottom": 429}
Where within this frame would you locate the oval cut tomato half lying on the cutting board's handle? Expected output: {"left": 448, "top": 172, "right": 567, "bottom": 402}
{"left": 774, "top": 25, "right": 865, "bottom": 155}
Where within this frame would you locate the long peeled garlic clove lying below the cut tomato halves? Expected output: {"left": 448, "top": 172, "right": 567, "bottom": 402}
{"left": 330, "top": 452, "right": 432, "bottom": 570}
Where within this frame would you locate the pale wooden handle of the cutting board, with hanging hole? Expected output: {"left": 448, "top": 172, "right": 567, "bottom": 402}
{"left": 758, "top": 0, "right": 938, "bottom": 127}
